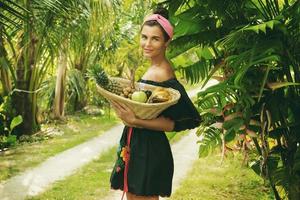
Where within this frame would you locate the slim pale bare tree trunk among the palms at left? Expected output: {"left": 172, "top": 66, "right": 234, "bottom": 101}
{"left": 53, "top": 48, "right": 67, "bottom": 119}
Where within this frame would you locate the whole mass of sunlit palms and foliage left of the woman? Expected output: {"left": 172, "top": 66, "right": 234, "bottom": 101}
{"left": 0, "top": 0, "right": 149, "bottom": 135}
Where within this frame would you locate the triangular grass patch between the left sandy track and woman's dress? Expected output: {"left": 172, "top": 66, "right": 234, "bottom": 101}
{"left": 27, "top": 147, "right": 116, "bottom": 200}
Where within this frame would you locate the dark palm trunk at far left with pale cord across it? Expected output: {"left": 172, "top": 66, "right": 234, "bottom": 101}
{"left": 12, "top": 1, "right": 40, "bottom": 135}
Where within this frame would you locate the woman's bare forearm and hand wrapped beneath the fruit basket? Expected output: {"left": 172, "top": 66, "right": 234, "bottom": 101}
{"left": 111, "top": 101, "right": 174, "bottom": 131}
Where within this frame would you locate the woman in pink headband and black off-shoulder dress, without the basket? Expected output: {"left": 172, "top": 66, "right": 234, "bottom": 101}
{"left": 111, "top": 9, "right": 201, "bottom": 200}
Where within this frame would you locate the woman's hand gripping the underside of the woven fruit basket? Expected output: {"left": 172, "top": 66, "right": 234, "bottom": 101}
{"left": 110, "top": 101, "right": 136, "bottom": 127}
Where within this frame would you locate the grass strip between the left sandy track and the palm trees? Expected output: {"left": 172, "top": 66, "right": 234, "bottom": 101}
{"left": 0, "top": 114, "right": 117, "bottom": 181}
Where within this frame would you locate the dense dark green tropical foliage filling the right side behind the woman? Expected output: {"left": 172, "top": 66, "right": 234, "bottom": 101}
{"left": 161, "top": 0, "right": 300, "bottom": 199}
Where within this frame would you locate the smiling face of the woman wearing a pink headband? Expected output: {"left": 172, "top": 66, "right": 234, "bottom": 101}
{"left": 140, "top": 25, "right": 168, "bottom": 58}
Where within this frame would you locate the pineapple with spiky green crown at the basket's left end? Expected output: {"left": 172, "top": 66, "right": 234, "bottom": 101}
{"left": 89, "top": 65, "right": 123, "bottom": 95}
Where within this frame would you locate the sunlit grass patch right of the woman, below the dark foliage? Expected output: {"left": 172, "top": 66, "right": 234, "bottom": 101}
{"left": 170, "top": 152, "right": 273, "bottom": 200}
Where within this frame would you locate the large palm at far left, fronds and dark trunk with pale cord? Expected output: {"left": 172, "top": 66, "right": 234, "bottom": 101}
{"left": 1, "top": 0, "right": 95, "bottom": 133}
